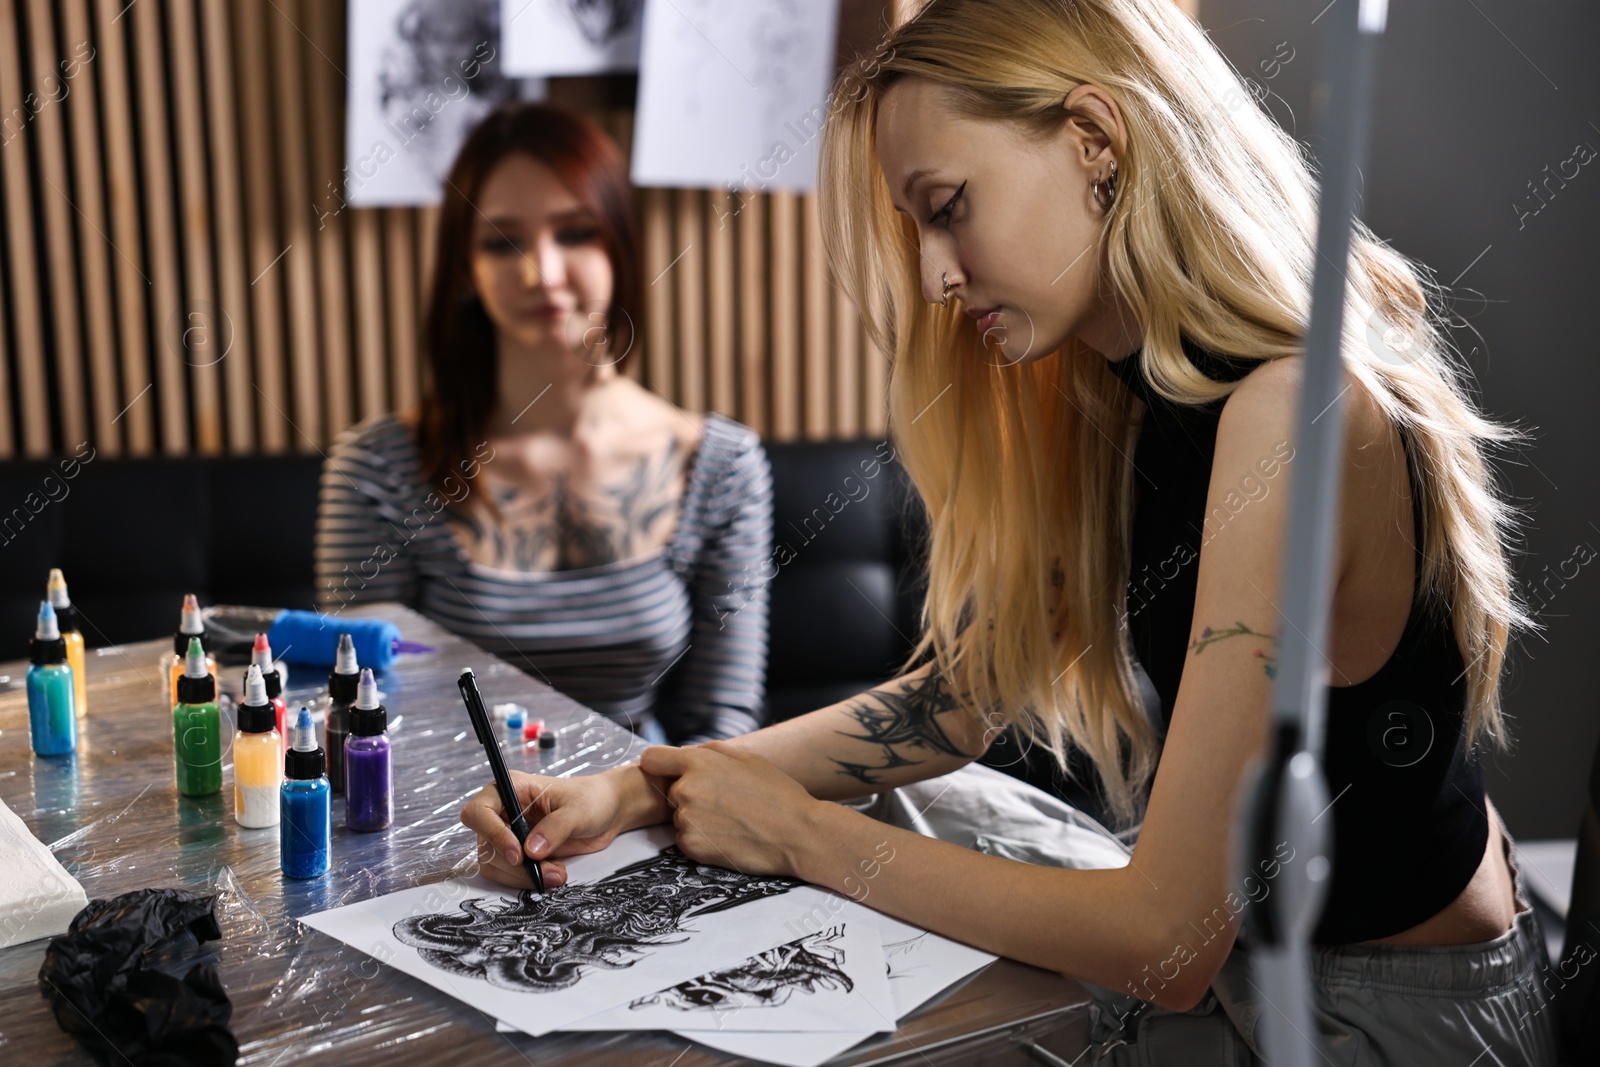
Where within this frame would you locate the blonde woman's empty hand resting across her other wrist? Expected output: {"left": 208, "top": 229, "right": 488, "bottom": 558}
{"left": 638, "top": 741, "right": 832, "bottom": 875}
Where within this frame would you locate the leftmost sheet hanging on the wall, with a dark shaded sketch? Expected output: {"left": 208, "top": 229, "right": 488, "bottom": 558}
{"left": 340, "top": 0, "right": 544, "bottom": 207}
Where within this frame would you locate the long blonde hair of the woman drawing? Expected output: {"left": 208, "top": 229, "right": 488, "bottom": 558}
{"left": 819, "top": 0, "right": 1538, "bottom": 821}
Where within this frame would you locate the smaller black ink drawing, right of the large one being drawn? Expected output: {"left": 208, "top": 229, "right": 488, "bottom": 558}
{"left": 629, "top": 923, "right": 856, "bottom": 1011}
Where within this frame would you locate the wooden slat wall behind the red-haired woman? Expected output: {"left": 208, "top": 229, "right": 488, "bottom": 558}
{"left": 0, "top": 0, "right": 1075, "bottom": 459}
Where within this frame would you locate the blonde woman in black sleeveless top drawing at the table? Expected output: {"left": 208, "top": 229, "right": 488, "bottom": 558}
{"left": 462, "top": 0, "right": 1554, "bottom": 1064}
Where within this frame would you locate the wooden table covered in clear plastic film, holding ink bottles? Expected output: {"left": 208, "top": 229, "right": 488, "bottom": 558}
{"left": 0, "top": 605, "right": 1088, "bottom": 1067}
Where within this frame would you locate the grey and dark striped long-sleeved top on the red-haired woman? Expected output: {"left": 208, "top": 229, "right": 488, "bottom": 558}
{"left": 317, "top": 413, "right": 773, "bottom": 744}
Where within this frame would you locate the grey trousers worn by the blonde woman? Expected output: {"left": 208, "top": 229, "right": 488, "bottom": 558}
{"left": 856, "top": 765, "right": 1557, "bottom": 1067}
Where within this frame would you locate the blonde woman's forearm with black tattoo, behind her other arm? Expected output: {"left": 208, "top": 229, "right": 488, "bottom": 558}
{"left": 728, "top": 665, "right": 997, "bottom": 800}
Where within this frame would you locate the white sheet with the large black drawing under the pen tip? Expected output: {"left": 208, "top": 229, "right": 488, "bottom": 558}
{"left": 301, "top": 827, "right": 857, "bottom": 1037}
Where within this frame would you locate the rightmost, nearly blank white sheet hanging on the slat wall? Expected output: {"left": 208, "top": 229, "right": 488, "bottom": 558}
{"left": 632, "top": 0, "right": 838, "bottom": 192}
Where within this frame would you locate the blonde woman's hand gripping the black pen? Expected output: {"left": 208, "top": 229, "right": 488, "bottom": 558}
{"left": 461, "top": 765, "right": 667, "bottom": 889}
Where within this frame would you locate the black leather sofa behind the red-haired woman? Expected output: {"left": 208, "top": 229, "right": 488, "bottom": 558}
{"left": 0, "top": 440, "right": 1120, "bottom": 817}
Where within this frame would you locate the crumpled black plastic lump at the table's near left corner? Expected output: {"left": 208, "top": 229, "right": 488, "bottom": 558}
{"left": 38, "top": 889, "right": 238, "bottom": 1067}
